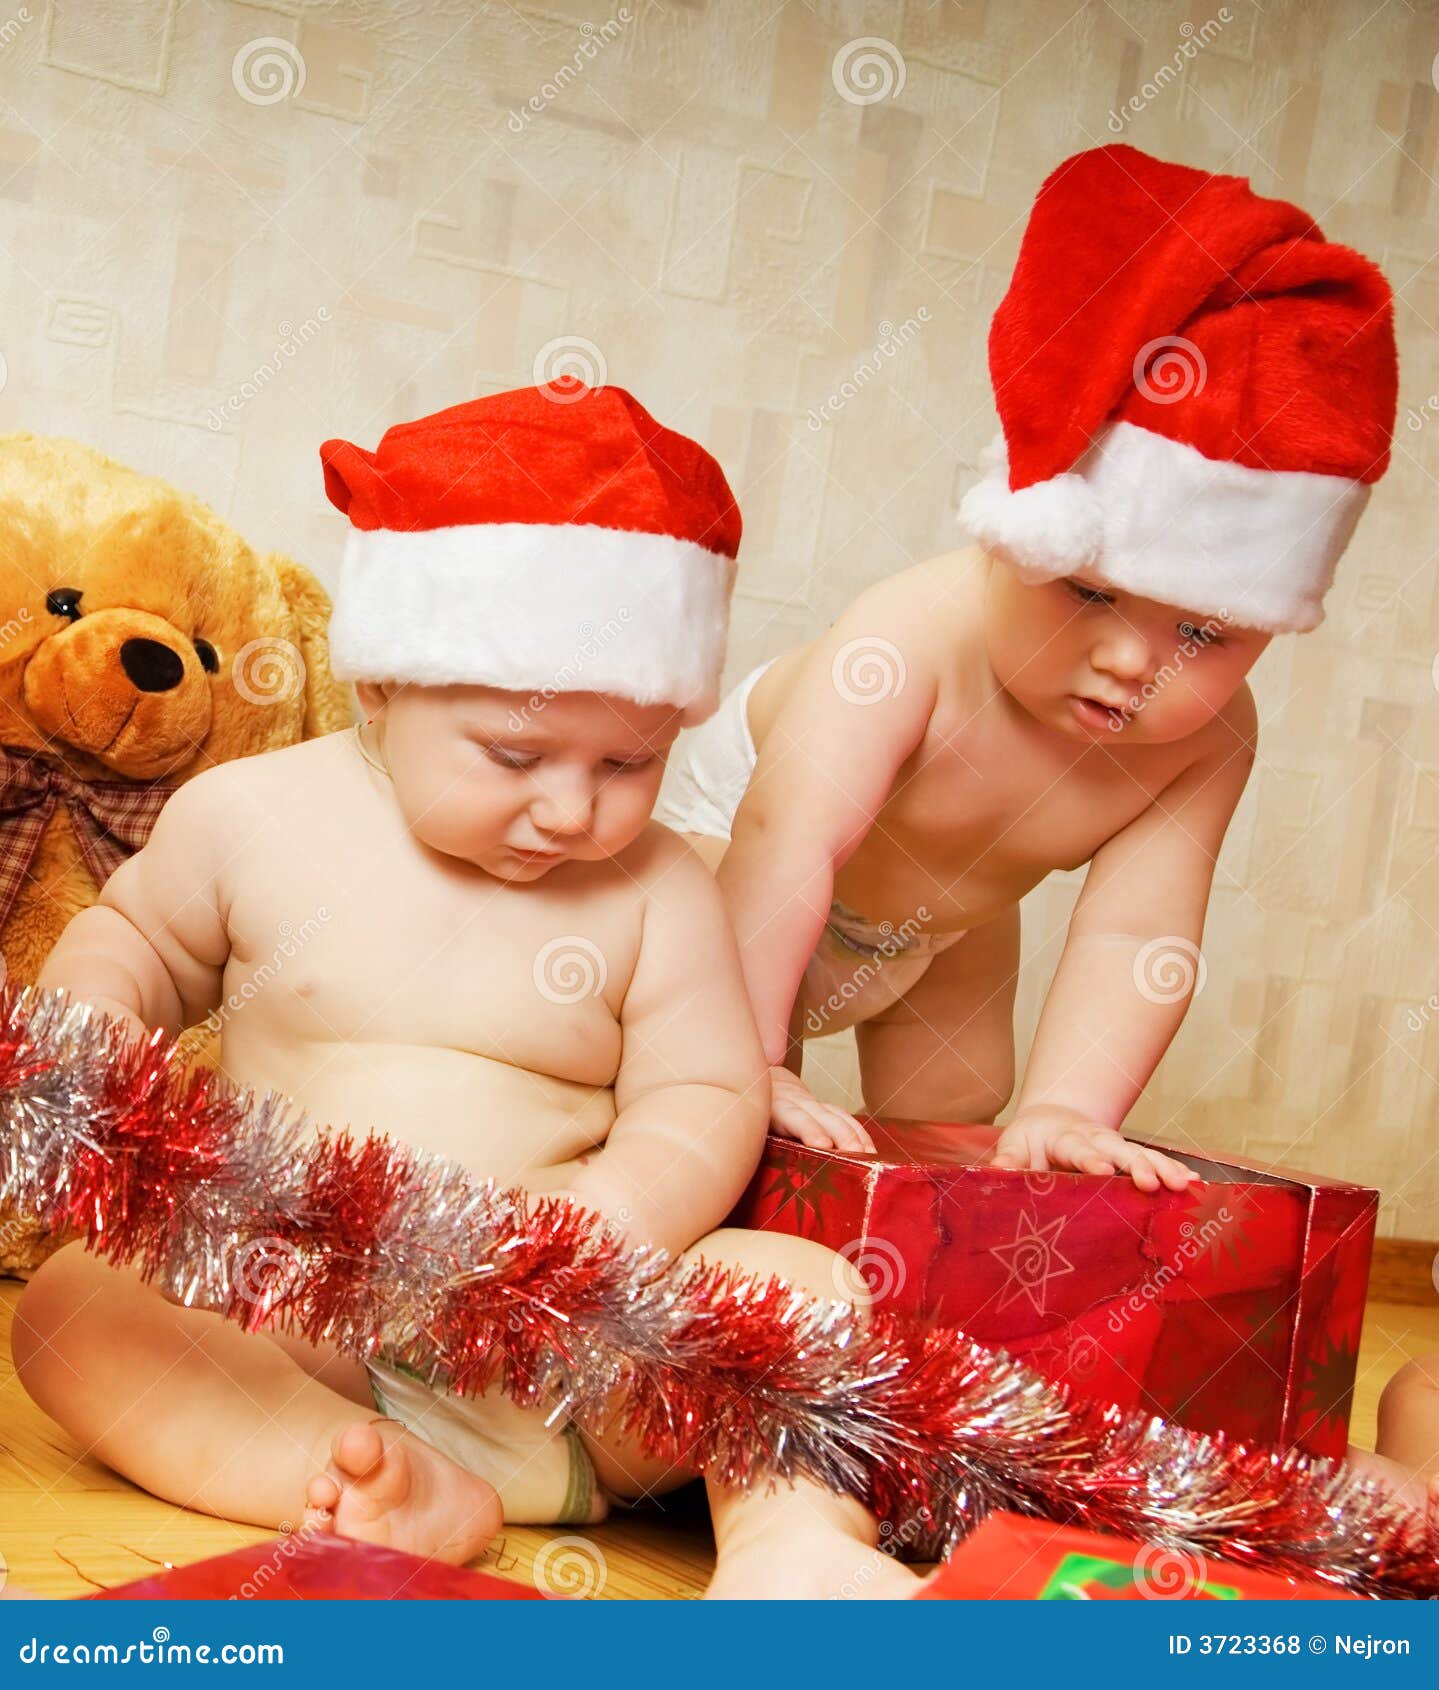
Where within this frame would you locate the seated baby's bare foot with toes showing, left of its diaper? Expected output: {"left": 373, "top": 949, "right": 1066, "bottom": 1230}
{"left": 304, "top": 1420, "right": 502, "bottom": 1563}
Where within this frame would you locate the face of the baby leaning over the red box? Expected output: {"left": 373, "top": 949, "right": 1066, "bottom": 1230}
{"left": 986, "top": 558, "right": 1270, "bottom": 745}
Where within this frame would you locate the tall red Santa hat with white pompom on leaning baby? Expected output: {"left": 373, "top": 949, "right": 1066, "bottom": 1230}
{"left": 960, "top": 145, "right": 1398, "bottom": 632}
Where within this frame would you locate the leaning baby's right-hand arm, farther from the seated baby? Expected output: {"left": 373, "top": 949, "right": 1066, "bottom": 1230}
{"left": 994, "top": 691, "right": 1255, "bottom": 1191}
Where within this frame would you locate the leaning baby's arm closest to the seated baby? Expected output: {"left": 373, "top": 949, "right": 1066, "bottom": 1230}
{"left": 717, "top": 581, "right": 938, "bottom": 1149}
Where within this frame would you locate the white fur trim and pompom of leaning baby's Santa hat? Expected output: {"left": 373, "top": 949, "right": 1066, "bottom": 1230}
{"left": 959, "top": 423, "right": 1370, "bottom": 634}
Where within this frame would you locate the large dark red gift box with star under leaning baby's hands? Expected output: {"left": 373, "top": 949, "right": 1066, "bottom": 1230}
{"left": 730, "top": 1120, "right": 1378, "bottom": 1455}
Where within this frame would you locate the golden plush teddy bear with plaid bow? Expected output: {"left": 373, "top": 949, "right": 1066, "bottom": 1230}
{"left": 0, "top": 433, "right": 353, "bottom": 1273}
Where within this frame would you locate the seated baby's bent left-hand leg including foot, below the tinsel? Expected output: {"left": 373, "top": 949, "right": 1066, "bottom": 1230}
{"left": 12, "top": 1244, "right": 499, "bottom": 1560}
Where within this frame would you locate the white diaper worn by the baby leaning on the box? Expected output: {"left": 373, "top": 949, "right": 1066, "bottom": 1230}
{"left": 654, "top": 659, "right": 964, "bottom": 1039}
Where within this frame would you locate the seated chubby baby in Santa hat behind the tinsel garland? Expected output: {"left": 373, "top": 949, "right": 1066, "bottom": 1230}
{"left": 14, "top": 382, "right": 915, "bottom": 1595}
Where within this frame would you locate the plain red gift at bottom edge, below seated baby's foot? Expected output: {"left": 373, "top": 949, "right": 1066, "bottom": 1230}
{"left": 88, "top": 1531, "right": 543, "bottom": 1602}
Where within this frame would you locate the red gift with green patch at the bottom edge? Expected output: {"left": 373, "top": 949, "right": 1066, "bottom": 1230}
{"left": 918, "top": 1513, "right": 1356, "bottom": 1602}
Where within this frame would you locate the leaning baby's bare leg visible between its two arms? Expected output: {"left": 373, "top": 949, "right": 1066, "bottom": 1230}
{"left": 854, "top": 908, "right": 1020, "bottom": 1120}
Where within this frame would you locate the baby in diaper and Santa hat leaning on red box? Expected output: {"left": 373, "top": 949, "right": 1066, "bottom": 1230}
{"left": 656, "top": 145, "right": 1397, "bottom": 1190}
